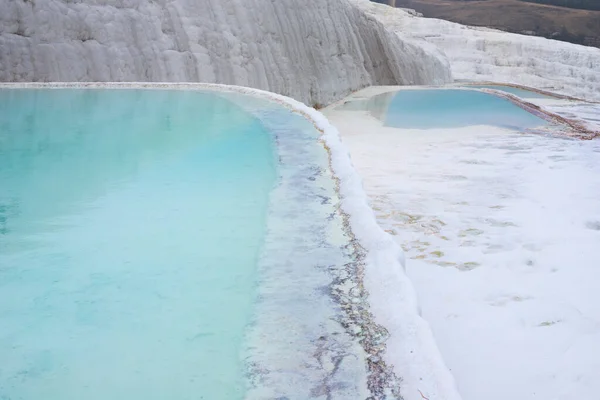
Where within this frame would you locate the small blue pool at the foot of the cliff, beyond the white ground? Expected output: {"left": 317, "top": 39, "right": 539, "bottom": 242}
{"left": 382, "top": 89, "right": 546, "bottom": 130}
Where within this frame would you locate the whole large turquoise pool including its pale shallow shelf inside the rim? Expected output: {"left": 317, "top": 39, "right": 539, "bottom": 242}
{"left": 0, "top": 89, "right": 365, "bottom": 400}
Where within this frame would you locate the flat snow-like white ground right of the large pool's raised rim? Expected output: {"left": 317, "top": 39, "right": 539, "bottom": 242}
{"left": 326, "top": 90, "right": 600, "bottom": 400}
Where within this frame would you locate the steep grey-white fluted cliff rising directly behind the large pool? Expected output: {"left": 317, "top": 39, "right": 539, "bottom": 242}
{"left": 0, "top": 0, "right": 450, "bottom": 104}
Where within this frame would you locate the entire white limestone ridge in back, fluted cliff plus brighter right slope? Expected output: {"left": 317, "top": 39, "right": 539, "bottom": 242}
{"left": 0, "top": 0, "right": 600, "bottom": 105}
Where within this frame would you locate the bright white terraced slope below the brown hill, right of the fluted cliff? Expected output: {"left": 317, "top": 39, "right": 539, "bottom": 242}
{"left": 375, "top": 5, "right": 600, "bottom": 100}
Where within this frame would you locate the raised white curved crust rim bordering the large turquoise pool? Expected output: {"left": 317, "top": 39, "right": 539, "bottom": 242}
{"left": 0, "top": 82, "right": 461, "bottom": 400}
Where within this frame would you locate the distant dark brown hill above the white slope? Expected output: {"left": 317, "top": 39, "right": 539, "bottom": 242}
{"left": 384, "top": 0, "right": 600, "bottom": 47}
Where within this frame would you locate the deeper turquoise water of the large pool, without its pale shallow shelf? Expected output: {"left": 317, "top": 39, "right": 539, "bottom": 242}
{"left": 0, "top": 89, "right": 276, "bottom": 400}
